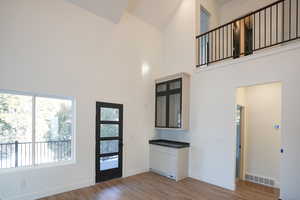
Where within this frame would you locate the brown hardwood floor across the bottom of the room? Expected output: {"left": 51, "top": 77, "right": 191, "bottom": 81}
{"left": 42, "top": 172, "right": 279, "bottom": 200}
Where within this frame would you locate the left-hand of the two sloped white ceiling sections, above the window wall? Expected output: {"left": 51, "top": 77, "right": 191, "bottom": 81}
{"left": 66, "top": 0, "right": 128, "bottom": 23}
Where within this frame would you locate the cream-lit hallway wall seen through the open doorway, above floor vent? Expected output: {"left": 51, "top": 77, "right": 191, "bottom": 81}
{"left": 237, "top": 83, "right": 282, "bottom": 187}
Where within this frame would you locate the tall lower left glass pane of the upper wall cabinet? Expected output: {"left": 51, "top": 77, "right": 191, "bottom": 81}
{"left": 156, "top": 96, "right": 167, "bottom": 127}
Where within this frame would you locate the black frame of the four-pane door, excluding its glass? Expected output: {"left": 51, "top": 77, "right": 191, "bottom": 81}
{"left": 95, "top": 102, "right": 123, "bottom": 183}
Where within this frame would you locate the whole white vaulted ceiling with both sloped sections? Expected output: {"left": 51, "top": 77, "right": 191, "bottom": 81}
{"left": 66, "top": 0, "right": 231, "bottom": 29}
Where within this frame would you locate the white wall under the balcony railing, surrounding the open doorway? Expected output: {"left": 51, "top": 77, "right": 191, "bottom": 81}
{"left": 160, "top": 0, "right": 300, "bottom": 200}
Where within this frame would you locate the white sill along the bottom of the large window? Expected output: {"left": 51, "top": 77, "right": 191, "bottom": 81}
{"left": 0, "top": 160, "right": 76, "bottom": 175}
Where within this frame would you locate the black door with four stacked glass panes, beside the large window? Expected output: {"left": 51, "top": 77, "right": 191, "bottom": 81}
{"left": 96, "top": 102, "right": 123, "bottom": 182}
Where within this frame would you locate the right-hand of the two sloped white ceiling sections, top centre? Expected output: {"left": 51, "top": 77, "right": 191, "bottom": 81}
{"left": 128, "top": 0, "right": 182, "bottom": 29}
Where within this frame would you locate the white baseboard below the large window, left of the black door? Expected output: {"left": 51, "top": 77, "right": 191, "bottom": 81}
{"left": 6, "top": 178, "right": 95, "bottom": 200}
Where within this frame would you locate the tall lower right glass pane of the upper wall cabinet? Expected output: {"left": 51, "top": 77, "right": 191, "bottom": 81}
{"left": 169, "top": 93, "right": 181, "bottom": 128}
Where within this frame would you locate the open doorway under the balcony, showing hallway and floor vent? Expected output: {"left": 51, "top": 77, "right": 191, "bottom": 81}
{"left": 235, "top": 82, "right": 282, "bottom": 193}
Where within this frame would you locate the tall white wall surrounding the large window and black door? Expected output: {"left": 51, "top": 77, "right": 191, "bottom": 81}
{"left": 0, "top": 0, "right": 162, "bottom": 200}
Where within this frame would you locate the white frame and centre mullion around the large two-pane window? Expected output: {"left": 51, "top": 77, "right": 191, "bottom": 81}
{"left": 0, "top": 89, "right": 76, "bottom": 174}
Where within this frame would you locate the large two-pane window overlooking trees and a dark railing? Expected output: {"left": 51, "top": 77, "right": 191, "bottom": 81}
{"left": 0, "top": 91, "right": 74, "bottom": 169}
